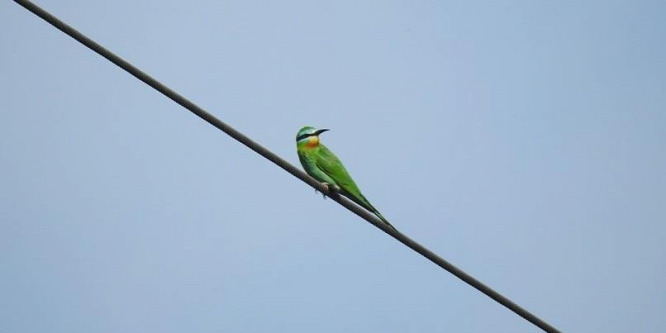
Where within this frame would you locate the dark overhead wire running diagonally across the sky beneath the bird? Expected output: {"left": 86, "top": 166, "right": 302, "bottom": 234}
{"left": 14, "top": 0, "right": 559, "bottom": 332}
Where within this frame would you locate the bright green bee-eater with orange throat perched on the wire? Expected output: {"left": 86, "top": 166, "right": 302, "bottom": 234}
{"left": 296, "top": 126, "right": 397, "bottom": 231}
